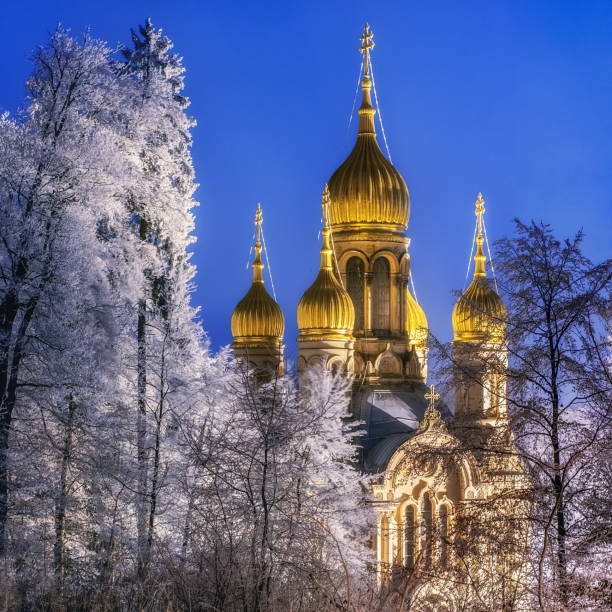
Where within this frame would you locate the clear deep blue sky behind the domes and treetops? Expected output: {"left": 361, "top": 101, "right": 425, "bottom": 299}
{"left": 0, "top": 0, "right": 612, "bottom": 357}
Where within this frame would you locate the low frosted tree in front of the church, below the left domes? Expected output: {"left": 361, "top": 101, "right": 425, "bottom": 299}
{"left": 177, "top": 364, "right": 376, "bottom": 610}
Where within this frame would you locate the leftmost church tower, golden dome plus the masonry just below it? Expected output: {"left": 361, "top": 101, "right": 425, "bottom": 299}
{"left": 232, "top": 204, "right": 285, "bottom": 376}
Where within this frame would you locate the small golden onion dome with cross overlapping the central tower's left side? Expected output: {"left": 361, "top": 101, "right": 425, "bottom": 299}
{"left": 297, "top": 185, "right": 355, "bottom": 339}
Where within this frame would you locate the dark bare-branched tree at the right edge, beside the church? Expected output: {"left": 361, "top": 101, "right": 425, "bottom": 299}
{"left": 496, "top": 221, "right": 612, "bottom": 609}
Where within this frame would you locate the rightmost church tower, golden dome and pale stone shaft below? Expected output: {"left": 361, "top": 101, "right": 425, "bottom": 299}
{"left": 453, "top": 193, "right": 508, "bottom": 421}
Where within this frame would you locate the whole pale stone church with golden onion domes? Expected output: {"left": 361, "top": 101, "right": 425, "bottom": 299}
{"left": 231, "top": 25, "right": 529, "bottom": 611}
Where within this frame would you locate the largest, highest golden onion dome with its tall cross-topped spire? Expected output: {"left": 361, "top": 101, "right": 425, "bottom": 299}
{"left": 329, "top": 24, "right": 410, "bottom": 231}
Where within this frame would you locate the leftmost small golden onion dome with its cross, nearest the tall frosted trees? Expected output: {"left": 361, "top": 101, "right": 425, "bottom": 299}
{"left": 232, "top": 204, "right": 285, "bottom": 345}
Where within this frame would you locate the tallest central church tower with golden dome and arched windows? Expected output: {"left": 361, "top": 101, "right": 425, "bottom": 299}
{"left": 322, "top": 24, "right": 427, "bottom": 385}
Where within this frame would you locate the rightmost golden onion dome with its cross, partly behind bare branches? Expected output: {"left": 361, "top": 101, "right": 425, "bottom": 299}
{"left": 453, "top": 193, "right": 508, "bottom": 342}
